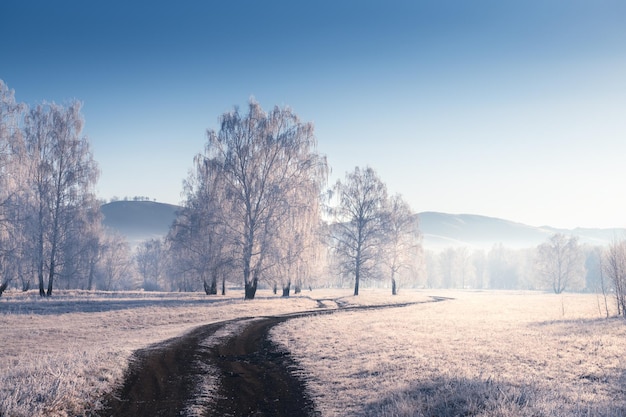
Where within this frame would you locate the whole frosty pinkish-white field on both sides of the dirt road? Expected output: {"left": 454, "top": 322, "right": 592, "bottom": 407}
{"left": 0, "top": 290, "right": 626, "bottom": 416}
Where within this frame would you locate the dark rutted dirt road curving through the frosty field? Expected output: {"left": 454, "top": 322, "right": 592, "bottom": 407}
{"left": 99, "top": 299, "right": 442, "bottom": 417}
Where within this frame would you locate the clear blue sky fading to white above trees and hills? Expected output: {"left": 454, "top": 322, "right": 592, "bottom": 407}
{"left": 0, "top": 0, "right": 626, "bottom": 227}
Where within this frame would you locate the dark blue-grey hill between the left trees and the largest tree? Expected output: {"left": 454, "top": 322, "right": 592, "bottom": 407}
{"left": 100, "top": 201, "right": 180, "bottom": 245}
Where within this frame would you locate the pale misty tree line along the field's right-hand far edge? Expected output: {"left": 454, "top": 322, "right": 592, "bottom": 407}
{"left": 418, "top": 233, "right": 626, "bottom": 316}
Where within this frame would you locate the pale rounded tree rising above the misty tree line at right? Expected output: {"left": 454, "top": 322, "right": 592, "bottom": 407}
{"left": 536, "top": 233, "right": 585, "bottom": 294}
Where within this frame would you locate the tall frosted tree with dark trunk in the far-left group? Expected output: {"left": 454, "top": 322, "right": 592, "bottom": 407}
{"left": 24, "top": 102, "right": 99, "bottom": 296}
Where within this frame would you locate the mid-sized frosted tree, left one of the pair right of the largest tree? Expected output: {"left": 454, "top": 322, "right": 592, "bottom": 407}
{"left": 332, "top": 167, "right": 387, "bottom": 295}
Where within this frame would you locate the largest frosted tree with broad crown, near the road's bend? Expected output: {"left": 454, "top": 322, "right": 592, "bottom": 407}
{"left": 205, "top": 100, "right": 326, "bottom": 299}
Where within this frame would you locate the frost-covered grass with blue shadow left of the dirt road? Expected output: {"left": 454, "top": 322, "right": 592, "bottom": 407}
{"left": 0, "top": 291, "right": 317, "bottom": 417}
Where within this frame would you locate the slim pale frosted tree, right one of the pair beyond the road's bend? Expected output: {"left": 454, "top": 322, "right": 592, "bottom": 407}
{"left": 383, "top": 194, "right": 420, "bottom": 295}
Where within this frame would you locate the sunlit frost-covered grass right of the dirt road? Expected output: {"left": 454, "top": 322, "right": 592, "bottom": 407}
{"left": 272, "top": 291, "right": 626, "bottom": 417}
